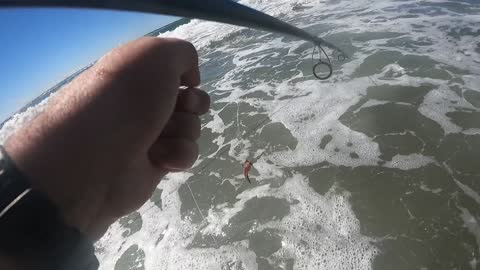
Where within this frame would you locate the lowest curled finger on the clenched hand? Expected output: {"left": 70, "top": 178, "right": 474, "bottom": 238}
{"left": 148, "top": 138, "right": 198, "bottom": 170}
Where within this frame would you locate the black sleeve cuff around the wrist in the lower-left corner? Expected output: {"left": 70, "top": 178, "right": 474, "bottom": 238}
{"left": 0, "top": 147, "right": 98, "bottom": 270}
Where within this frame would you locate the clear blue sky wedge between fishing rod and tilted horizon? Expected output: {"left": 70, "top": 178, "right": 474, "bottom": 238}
{"left": 0, "top": 8, "right": 177, "bottom": 122}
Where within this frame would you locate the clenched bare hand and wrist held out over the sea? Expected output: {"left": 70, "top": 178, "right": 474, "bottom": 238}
{"left": 5, "top": 38, "right": 210, "bottom": 240}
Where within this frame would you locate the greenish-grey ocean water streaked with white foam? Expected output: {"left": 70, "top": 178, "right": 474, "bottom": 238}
{"left": 0, "top": 0, "right": 480, "bottom": 270}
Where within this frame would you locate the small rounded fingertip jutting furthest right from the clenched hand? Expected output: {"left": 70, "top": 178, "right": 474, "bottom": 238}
{"left": 175, "top": 88, "right": 210, "bottom": 115}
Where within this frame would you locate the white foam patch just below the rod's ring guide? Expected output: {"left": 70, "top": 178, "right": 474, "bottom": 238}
{"left": 260, "top": 78, "right": 380, "bottom": 167}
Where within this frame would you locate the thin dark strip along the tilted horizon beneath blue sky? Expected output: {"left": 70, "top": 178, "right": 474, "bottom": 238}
{"left": 0, "top": 18, "right": 191, "bottom": 129}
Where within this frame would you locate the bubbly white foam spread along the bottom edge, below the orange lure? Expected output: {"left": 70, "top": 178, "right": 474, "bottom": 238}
{"left": 97, "top": 168, "right": 377, "bottom": 269}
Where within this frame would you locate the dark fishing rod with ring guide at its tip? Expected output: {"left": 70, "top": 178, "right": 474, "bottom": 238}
{"left": 0, "top": 0, "right": 347, "bottom": 80}
